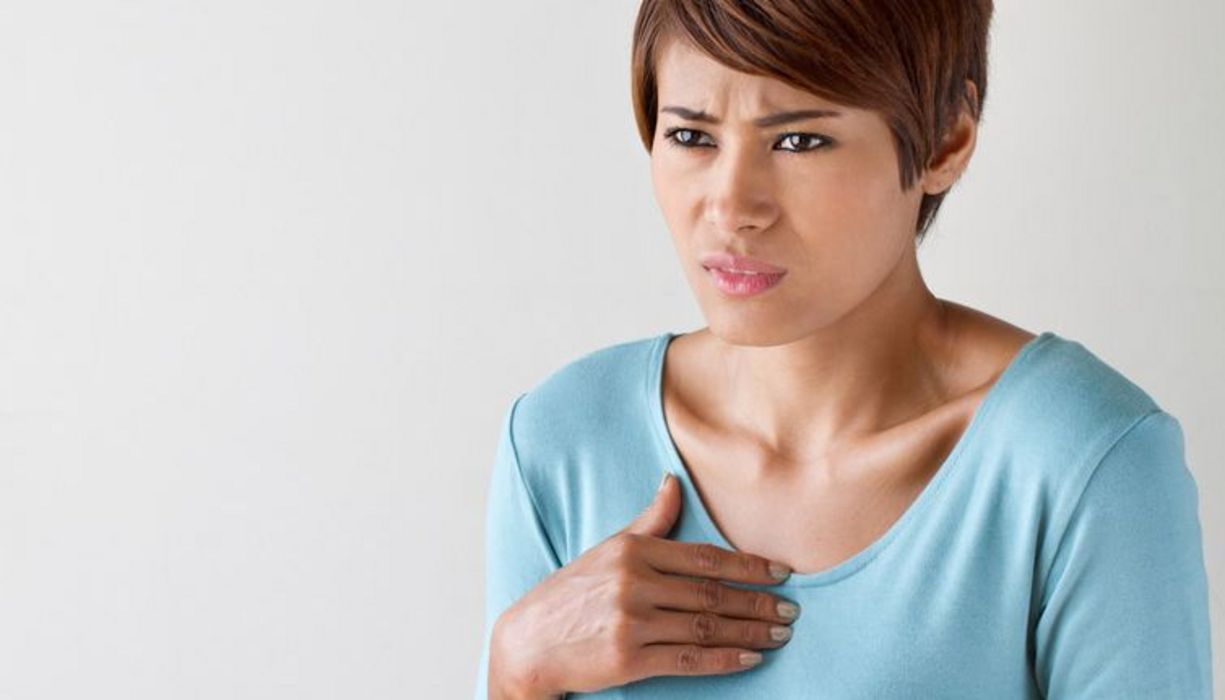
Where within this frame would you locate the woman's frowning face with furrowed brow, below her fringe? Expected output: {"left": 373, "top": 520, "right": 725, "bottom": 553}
{"left": 650, "top": 40, "right": 924, "bottom": 346}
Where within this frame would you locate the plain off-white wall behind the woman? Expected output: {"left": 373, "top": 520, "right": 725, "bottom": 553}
{"left": 0, "top": 0, "right": 1225, "bottom": 700}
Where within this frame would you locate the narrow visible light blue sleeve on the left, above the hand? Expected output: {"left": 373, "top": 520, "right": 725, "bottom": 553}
{"left": 474, "top": 394, "right": 561, "bottom": 700}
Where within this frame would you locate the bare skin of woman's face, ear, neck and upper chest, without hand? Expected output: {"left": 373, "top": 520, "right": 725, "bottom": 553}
{"left": 650, "top": 34, "right": 1034, "bottom": 573}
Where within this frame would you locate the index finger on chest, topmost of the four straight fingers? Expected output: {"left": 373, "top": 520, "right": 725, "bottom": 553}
{"left": 642, "top": 537, "right": 791, "bottom": 585}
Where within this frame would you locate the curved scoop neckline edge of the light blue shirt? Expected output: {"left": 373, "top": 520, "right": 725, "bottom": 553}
{"left": 646, "top": 331, "right": 1055, "bottom": 588}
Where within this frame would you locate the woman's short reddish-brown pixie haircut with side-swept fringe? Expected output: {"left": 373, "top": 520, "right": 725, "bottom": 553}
{"left": 631, "top": 0, "right": 992, "bottom": 243}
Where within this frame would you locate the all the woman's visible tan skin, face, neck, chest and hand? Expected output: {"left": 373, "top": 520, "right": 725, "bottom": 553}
{"left": 489, "top": 34, "right": 1034, "bottom": 698}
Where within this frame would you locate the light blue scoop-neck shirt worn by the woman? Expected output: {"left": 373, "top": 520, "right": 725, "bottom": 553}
{"left": 477, "top": 331, "right": 1212, "bottom": 700}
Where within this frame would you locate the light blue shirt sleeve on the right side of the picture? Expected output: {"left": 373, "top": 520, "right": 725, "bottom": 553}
{"left": 1034, "top": 409, "right": 1213, "bottom": 700}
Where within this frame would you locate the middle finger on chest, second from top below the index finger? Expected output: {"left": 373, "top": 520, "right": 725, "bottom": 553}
{"left": 641, "top": 574, "right": 800, "bottom": 624}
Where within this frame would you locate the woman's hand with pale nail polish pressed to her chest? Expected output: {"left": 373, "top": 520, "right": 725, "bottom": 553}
{"left": 490, "top": 474, "right": 799, "bottom": 698}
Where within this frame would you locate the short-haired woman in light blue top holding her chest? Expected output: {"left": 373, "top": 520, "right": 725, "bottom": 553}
{"left": 477, "top": 0, "right": 1212, "bottom": 699}
